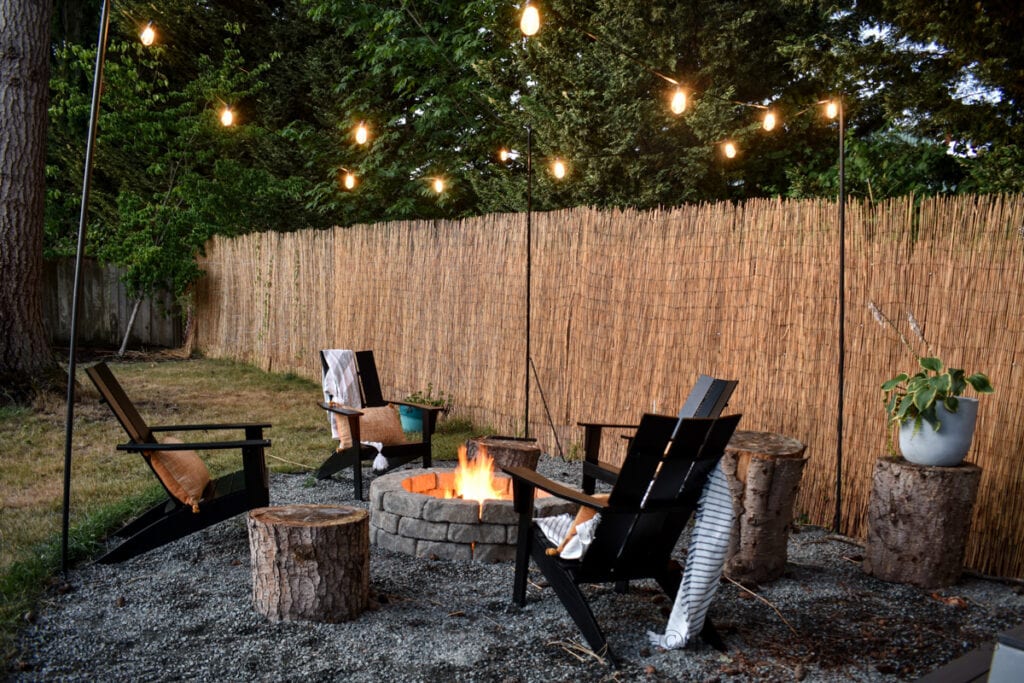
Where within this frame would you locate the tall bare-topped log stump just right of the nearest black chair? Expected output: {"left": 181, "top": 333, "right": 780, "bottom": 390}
{"left": 722, "top": 430, "right": 807, "bottom": 584}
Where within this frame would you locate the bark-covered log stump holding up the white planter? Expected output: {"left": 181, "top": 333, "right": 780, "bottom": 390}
{"left": 863, "top": 458, "right": 981, "bottom": 588}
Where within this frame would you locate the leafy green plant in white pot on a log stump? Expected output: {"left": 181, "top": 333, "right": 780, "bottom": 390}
{"left": 871, "top": 304, "right": 993, "bottom": 467}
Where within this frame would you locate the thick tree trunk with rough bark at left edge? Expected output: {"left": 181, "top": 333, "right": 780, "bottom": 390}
{"left": 0, "top": 0, "right": 61, "bottom": 403}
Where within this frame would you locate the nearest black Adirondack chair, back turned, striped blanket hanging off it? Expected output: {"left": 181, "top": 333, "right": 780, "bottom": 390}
{"left": 505, "top": 414, "right": 739, "bottom": 664}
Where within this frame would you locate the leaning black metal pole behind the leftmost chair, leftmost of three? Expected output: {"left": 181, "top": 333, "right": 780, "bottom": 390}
{"left": 60, "top": 0, "right": 111, "bottom": 572}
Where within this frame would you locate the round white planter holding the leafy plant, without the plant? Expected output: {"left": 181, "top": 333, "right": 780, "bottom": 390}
{"left": 899, "top": 397, "right": 978, "bottom": 467}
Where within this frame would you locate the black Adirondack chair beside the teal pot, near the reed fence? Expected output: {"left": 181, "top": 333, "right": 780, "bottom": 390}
{"left": 316, "top": 351, "right": 444, "bottom": 501}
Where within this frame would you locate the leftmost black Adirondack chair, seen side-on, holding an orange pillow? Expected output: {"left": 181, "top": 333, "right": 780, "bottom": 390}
{"left": 85, "top": 362, "right": 270, "bottom": 563}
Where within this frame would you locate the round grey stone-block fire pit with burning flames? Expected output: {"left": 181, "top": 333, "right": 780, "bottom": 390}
{"left": 370, "top": 454, "right": 575, "bottom": 562}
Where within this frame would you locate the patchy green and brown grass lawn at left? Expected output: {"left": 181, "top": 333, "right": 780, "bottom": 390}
{"left": 0, "top": 359, "right": 486, "bottom": 660}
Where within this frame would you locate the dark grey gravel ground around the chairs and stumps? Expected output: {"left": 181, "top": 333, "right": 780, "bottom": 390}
{"left": 8, "top": 457, "right": 1024, "bottom": 683}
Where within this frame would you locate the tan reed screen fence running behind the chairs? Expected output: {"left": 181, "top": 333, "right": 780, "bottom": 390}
{"left": 196, "top": 196, "right": 1024, "bottom": 577}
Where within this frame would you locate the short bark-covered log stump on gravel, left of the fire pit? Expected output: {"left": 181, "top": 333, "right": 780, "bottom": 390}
{"left": 248, "top": 505, "right": 370, "bottom": 623}
